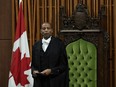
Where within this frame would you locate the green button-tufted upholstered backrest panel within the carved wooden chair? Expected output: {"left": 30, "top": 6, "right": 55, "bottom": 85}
{"left": 66, "top": 39, "right": 97, "bottom": 87}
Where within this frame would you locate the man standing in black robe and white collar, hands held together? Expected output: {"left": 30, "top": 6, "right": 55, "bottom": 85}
{"left": 31, "top": 23, "right": 69, "bottom": 87}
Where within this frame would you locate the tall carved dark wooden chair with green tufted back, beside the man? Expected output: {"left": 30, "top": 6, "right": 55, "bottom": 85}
{"left": 58, "top": 3, "right": 110, "bottom": 87}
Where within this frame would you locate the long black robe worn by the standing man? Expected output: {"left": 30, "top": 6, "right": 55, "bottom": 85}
{"left": 31, "top": 37, "right": 69, "bottom": 87}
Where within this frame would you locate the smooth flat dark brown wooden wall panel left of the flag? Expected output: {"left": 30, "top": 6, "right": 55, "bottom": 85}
{"left": 0, "top": 0, "right": 12, "bottom": 87}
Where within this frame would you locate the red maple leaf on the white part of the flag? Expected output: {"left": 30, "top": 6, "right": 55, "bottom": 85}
{"left": 11, "top": 48, "right": 30, "bottom": 86}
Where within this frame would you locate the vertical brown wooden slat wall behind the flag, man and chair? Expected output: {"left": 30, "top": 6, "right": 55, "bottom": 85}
{"left": 12, "top": 0, "right": 116, "bottom": 87}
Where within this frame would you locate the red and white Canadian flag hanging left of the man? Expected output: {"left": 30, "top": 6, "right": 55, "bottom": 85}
{"left": 8, "top": 2, "right": 33, "bottom": 87}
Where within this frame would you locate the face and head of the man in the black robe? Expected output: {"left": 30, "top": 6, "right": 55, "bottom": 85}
{"left": 41, "top": 23, "right": 53, "bottom": 39}
